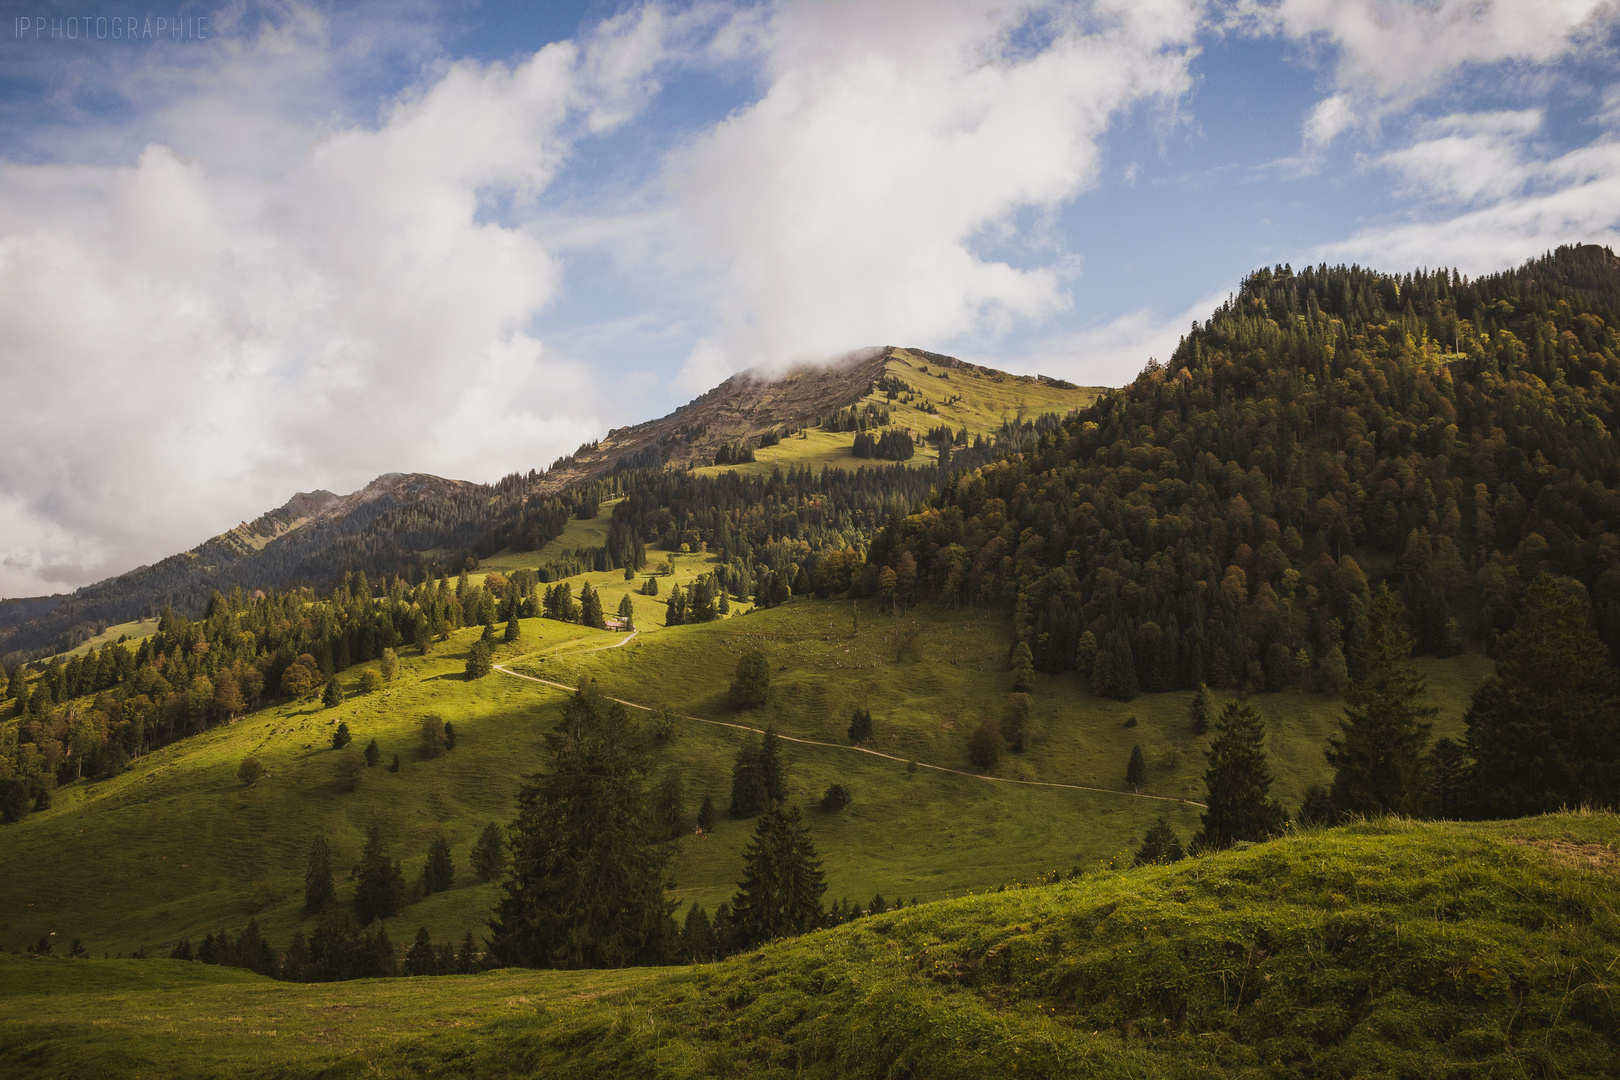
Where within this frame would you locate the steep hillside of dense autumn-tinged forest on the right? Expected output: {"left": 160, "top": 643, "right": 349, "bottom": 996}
{"left": 870, "top": 246, "right": 1620, "bottom": 698}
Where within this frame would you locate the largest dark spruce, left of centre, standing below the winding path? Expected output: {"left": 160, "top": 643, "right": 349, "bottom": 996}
{"left": 489, "top": 682, "right": 677, "bottom": 968}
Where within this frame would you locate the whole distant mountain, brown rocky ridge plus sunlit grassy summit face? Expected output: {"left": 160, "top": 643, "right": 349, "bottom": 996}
{"left": 0, "top": 347, "right": 1095, "bottom": 664}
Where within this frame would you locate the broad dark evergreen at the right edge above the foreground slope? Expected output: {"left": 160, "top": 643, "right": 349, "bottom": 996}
{"left": 1464, "top": 572, "right": 1620, "bottom": 818}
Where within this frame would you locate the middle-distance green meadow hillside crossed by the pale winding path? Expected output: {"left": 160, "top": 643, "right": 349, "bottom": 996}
{"left": 0, "top": 555, "right": 1486, "bottom": 955}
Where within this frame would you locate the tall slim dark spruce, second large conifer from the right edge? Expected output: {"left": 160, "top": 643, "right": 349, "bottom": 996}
{"left": 1327, "top": 586, "right": 1439, "bottom": 816}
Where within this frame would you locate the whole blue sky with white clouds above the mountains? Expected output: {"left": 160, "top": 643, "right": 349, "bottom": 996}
{"left": 0, "top": 0, "right": 1620, "bottom": 597}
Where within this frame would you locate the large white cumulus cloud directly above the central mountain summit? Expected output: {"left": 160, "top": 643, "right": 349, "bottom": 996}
{"left": 669, "top": 0, "right": 1197, "bottom": 389}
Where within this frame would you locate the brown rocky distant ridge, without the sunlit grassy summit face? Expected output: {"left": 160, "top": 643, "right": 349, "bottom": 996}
{"left": 0, "top": 347, "right": 1069, "bottom": 664}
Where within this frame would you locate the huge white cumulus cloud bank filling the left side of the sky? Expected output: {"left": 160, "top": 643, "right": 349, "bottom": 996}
{"left": 0, "top": 10, "right": 682, "bottom": 596}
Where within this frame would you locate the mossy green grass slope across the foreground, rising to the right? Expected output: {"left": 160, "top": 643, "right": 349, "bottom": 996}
{"left": 0, "top": 814, "right": 1620, "bottom": 1078}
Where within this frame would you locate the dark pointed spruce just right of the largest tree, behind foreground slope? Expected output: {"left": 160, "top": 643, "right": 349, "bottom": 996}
{"left": 731, "top": 803, "right": 826, "bottom": 946}
